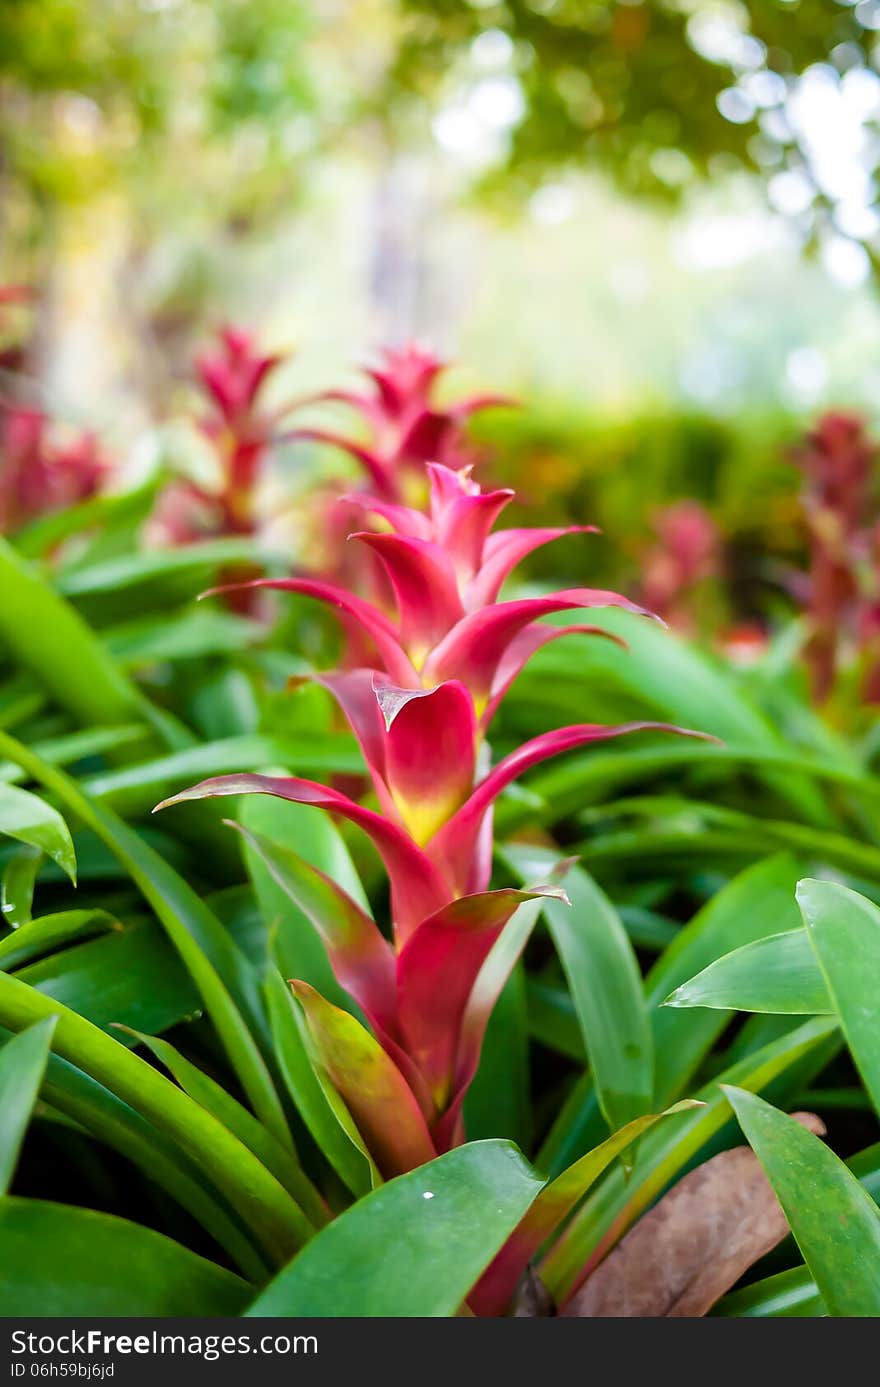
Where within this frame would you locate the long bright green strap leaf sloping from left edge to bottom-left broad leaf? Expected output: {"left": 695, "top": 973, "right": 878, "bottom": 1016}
{"left": 0, "top": 974, "right": 312, "bottom": 1261}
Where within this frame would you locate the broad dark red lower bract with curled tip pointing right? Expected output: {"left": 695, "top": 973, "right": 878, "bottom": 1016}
{"left": 397, "top": 886, "right": 566, "bottom": 1108}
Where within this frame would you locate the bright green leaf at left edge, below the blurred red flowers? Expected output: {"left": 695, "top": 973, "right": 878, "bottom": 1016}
{"left": 0, "top": 535, "right": 143, "bottom": 727}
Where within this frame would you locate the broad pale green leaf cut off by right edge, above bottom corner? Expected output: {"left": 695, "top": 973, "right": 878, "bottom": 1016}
{"left": 798, "top": 881, "right": 880, "bottom": 1112}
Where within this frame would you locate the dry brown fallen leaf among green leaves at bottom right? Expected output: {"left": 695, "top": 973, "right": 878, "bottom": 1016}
{"left": 559, "top": 1112, "right": 824, "bottom": 1319}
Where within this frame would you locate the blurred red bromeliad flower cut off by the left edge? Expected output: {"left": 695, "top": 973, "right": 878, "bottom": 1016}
{"left": 0, "top": 408, "right": 108, "bottom": 531}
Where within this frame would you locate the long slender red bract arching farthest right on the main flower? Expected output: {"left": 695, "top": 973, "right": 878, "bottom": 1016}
{"left": 428, "top": 723, "right": 705, "bottom": 890}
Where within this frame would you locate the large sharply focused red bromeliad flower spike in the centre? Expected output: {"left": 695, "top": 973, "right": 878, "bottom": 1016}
{"left": 156, "top": 454, "right": 705, "bottom": 1175}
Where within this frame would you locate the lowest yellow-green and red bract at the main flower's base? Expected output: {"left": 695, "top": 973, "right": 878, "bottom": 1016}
{"left": 290, "top": 981, "right": 437, "bottom": 1178}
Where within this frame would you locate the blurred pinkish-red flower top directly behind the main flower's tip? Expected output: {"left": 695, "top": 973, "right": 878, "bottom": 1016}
{"left": 290, "top": 343, "right": 512, "bottom": 501}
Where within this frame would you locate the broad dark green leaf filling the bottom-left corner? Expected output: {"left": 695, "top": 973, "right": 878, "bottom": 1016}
{"left": 0, "top": 1196, "right": 250, "bottom": 1319}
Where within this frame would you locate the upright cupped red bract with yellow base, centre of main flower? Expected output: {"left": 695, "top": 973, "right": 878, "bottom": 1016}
{"left": 373, "top": 681, "right": 476, "bottom": 846}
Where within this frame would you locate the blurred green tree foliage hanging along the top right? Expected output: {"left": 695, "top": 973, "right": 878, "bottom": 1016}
{"left": 396, "top": 0, "right": 876, "bottom": 196}
